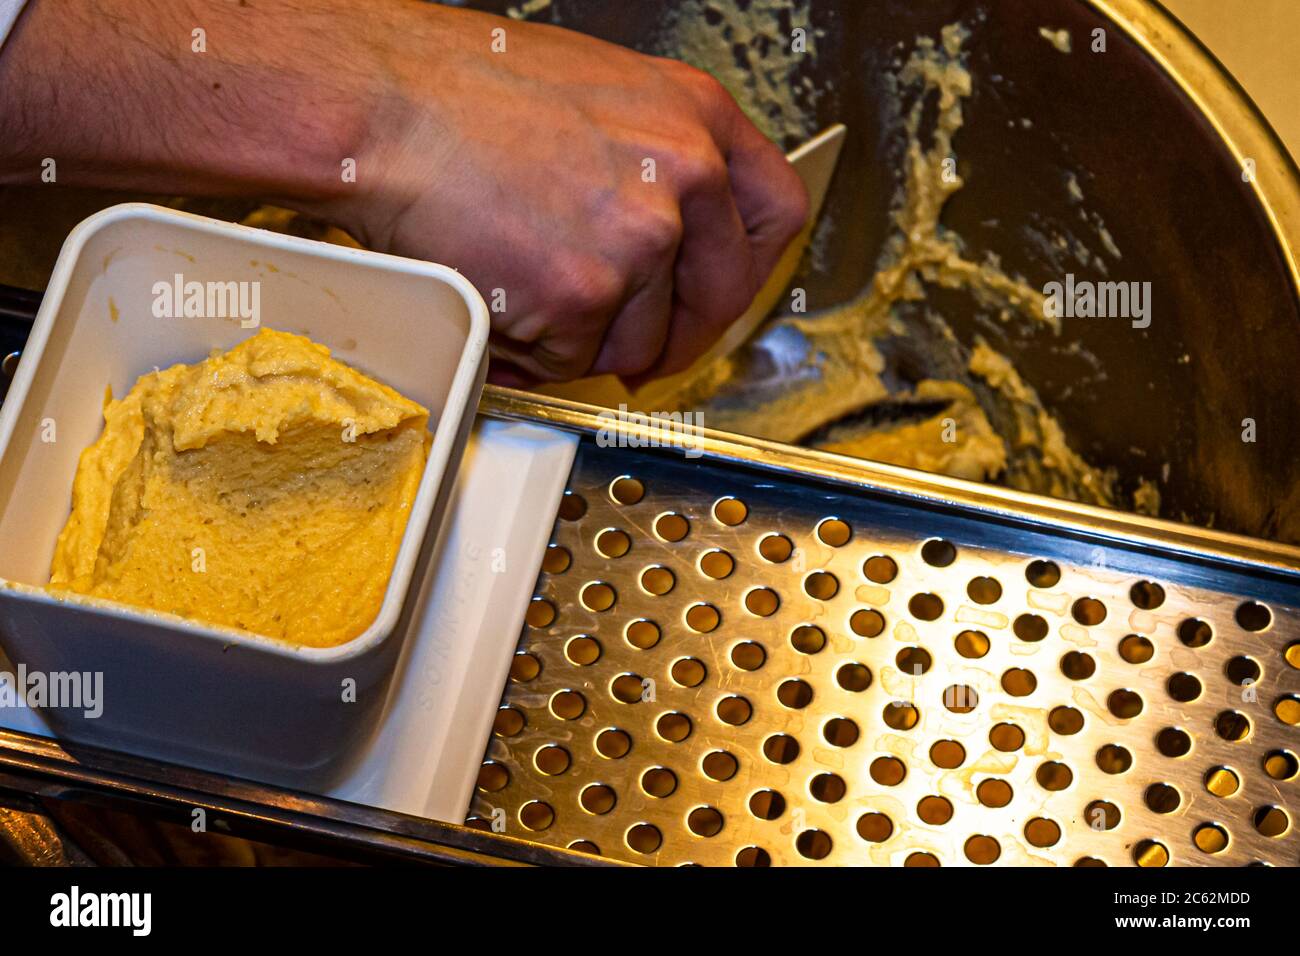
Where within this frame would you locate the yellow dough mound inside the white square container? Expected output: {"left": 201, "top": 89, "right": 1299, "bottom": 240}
{"left": 48, "top": 329, "right": 429, "bottom": 646}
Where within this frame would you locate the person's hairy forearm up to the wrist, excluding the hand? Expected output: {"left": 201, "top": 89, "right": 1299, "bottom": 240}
{"left": 0, "top": 0, "right": 381, "bottom": 200}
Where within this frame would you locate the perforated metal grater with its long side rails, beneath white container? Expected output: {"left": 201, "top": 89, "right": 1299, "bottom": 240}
{"left": 0, "top": 388, "right": 1300, "bottom": 865}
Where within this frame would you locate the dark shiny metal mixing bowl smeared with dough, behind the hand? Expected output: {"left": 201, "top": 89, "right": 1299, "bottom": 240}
{"left": 471, "top": 0, "right": 1300, "bottom": 541}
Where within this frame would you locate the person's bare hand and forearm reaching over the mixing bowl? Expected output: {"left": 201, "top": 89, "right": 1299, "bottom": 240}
{"left": 0, "top": 0, "right": 807, "bottom": 384}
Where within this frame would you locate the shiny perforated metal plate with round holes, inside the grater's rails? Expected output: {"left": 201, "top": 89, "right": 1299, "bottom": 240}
{"left": 469, "top": 440, "right": 1300, "bottom": 866}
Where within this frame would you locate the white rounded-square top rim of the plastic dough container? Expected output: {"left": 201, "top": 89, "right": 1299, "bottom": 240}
{"left": 0, "top": 203, "right": 490, "bottom": 665}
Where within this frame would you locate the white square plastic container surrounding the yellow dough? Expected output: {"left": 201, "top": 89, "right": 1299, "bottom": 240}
{"left": 0, "top": 203, "right": 489, "bottom": 780}
